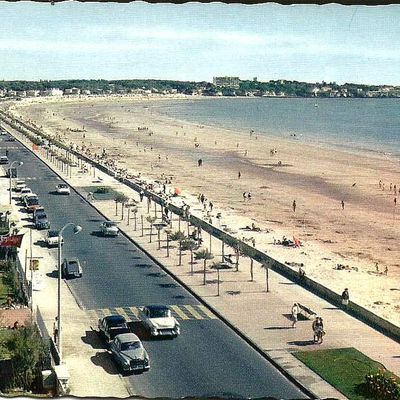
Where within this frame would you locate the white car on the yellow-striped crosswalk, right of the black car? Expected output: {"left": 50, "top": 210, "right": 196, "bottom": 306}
{"left": 140, "top": 305, "right": 181, "bottom": 337}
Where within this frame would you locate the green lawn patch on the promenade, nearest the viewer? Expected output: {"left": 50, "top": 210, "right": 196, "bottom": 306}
{"left": 293, "top": 347, "right": 390, "bottom": 400}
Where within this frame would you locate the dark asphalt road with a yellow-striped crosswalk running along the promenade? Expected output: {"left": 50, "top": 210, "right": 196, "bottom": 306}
{"left": 0, "top": 137, "right": 307, "bottom": 399}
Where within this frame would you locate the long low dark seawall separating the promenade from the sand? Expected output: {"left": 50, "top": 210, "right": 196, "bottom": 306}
{"left": 0, "top": 108, "right": 400, "bottom": 343}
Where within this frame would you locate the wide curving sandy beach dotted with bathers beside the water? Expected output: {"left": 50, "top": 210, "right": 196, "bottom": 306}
{"left": 2, "top": 97, "right": 400, "bottom": 325}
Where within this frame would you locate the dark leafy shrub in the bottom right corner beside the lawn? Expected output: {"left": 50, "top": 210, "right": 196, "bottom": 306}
{"left": 365, "top": 370, "right": 400, "bottom": 400}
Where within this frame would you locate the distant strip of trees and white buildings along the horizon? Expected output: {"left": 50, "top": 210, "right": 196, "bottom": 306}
{"left": 0, "top": 76, "right": 400, "bottom": 99}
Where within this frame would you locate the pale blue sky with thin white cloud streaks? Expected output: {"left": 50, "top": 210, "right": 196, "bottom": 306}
{"left": 0, "top": 1, "right": 400, "bottom": 85}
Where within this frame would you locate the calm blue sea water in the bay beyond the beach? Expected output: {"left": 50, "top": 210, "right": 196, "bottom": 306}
{"left": 152, "top": 98, "right": 400, "bottom": 159}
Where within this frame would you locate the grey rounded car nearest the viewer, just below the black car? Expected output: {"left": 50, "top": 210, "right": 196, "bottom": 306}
{"left": 110, "top": 333, "right": 150, "bottom": 373}
